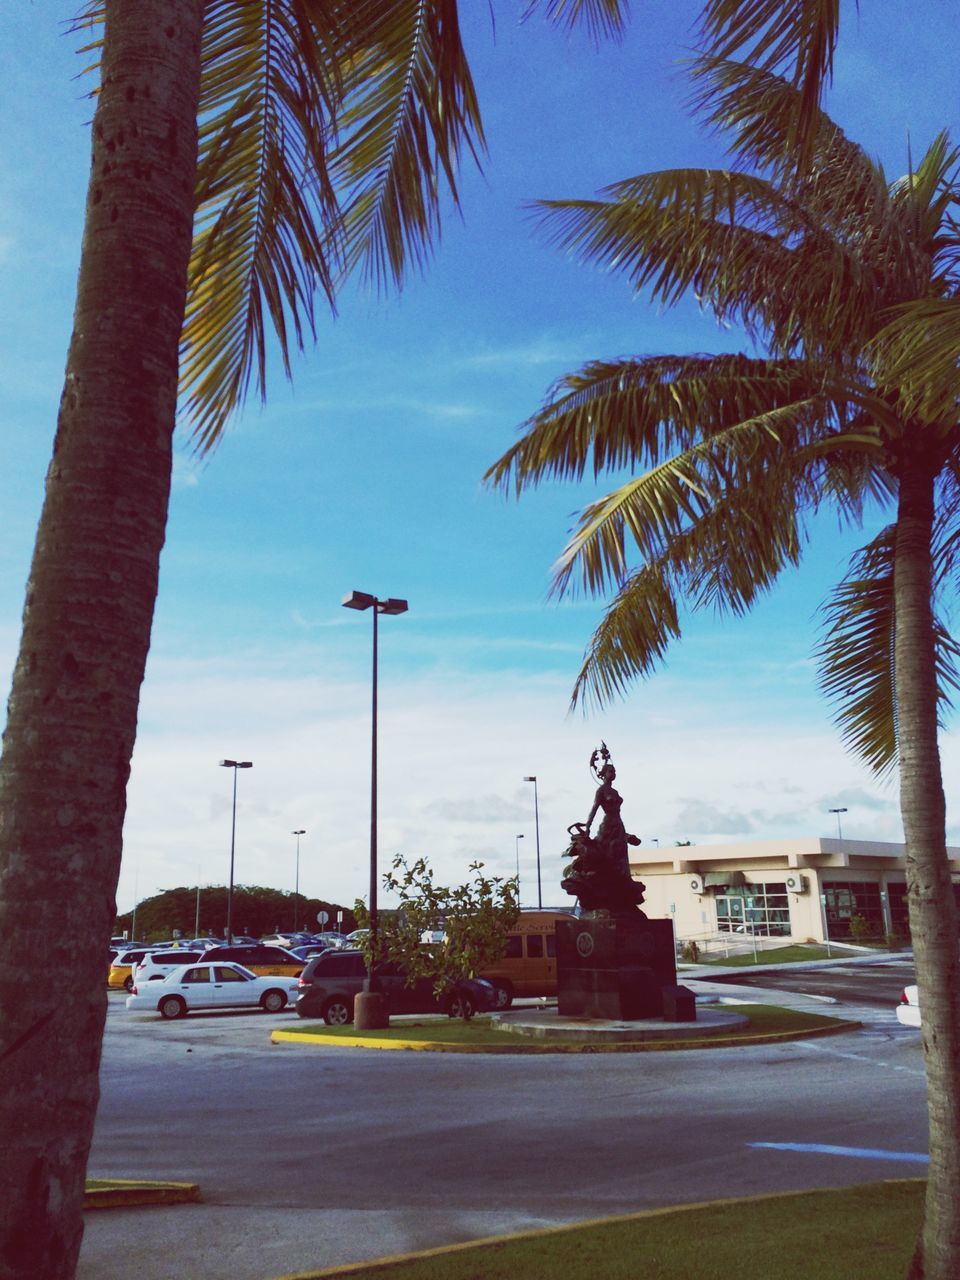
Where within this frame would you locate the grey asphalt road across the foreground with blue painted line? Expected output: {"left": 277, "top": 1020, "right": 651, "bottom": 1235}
{"left": 79, "top": 970, "right": 925, "bottom": 1280}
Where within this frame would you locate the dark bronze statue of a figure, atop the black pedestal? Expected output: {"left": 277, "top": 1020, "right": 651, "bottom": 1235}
{"left": 561, "top": 742, "right": 645, "bottom": 918}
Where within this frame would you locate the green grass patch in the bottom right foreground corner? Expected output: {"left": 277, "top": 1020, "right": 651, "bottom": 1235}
{"left": 304, "top": 1181, "right": 923, "bottom": 1280}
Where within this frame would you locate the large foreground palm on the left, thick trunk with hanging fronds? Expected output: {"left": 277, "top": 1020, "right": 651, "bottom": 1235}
{"left": 0, "top": 0, "right": 625, "bottom": 1280}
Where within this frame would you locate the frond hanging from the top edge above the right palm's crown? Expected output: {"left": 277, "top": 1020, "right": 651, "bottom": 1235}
{"left": 700, "top": 0, "right": 840, "bottom": 170}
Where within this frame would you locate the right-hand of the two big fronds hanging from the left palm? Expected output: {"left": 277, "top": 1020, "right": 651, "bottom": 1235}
{"left": 330, "top": 0, "right": 484, "bottom": 288}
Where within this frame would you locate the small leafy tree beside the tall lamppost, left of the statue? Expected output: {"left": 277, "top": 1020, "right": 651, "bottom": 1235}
{"left": 353, "top": 854, "right": 520, "bottom": 1020}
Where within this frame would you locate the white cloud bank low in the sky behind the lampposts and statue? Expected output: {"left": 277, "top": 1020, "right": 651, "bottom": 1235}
{"left": 112, "top": 657, "right": 900, "bottom": 908}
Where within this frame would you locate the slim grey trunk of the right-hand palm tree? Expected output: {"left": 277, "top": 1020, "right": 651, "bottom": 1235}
{"left": 893, "top": 457, "right": 960, "bottom": 1280}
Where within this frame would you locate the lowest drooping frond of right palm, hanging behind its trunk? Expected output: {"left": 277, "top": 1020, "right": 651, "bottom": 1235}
{"left": 817, "top": 525, "right": 960, "bottom": 777}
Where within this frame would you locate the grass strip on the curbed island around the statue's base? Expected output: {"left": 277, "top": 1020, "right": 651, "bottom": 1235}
{"left": 285, "top": 1005, "right": 844, "bottom": 1053}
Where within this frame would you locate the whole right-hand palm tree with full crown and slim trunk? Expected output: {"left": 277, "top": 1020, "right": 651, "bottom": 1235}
{"left": 486, "top": 59, "right": 960, "bottom": 1280}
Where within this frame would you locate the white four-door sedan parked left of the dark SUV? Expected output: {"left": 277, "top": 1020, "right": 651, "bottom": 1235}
{"left": 127, "top": 963, "right": 298, "bottom": 1018}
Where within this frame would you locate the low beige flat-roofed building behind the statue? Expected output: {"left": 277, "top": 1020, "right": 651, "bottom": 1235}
{"left": 630, "top": 838, "right": 960, "bottom": 942}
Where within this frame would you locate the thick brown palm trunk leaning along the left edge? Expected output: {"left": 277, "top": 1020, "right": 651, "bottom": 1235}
{"left": 0, "top": 0, "right": 204, "bottom": 1280}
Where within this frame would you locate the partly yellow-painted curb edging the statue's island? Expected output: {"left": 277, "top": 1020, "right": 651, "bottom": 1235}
{"left": 270, "top": 1020, "right": 863, "bottom": 1053}
